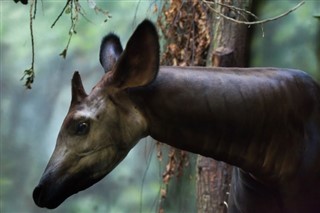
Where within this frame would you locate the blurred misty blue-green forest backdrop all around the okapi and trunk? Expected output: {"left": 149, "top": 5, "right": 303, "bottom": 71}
{"left": 0, "top": 0, "right": 320, "bottom": 213}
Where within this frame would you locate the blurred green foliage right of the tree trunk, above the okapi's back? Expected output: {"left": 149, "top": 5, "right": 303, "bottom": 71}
{"left": 251, "top": 0, "right": 320, "bottom": 81}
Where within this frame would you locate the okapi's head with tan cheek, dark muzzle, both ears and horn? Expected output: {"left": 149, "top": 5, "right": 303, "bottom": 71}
{"left": 33, "top": 20, "right": 159, "bottom": 208}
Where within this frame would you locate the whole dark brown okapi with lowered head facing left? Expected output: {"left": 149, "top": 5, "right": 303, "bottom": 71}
{"left": 33, "top": 20, "right": 320, "bottom": 213}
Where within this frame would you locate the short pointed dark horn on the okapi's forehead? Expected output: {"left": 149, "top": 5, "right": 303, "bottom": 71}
{"left": 71, "top": 71, "right": 87, "bottom": 105}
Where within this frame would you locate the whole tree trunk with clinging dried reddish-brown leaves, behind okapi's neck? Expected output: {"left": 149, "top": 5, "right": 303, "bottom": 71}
{"left": 155, "top": 0, "right": 252, "bottom": 213}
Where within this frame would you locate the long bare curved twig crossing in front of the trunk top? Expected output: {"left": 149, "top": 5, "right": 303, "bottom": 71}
{"left": 203, "top": 0, "right": 305, "bottom": 25}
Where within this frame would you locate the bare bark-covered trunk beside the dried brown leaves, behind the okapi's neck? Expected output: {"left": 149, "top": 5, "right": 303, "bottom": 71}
{"left": 197, "top": 0, "right": 251, "bottom": 213}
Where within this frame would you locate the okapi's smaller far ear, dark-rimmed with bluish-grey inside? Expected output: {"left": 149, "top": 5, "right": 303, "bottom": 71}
{"left": 99, "top": 33, "right": 123, "bottom": 72}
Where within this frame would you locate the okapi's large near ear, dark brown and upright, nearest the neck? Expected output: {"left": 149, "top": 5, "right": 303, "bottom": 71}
{"left": 111, "top": 20, "right": 160, "bottom": 89}
